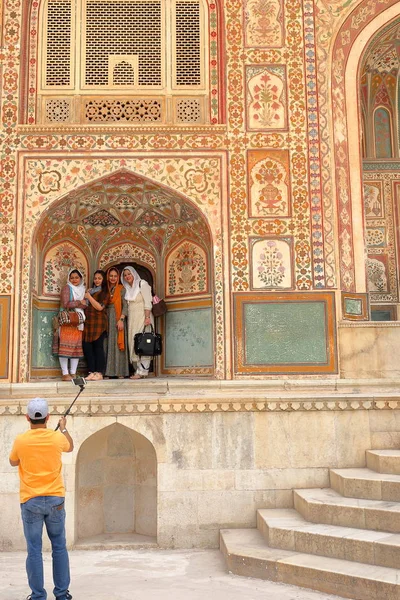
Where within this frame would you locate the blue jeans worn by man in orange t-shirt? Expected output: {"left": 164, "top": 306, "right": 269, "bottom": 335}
{"left": 21, "top": 496, "right": 70, "bottom": 600}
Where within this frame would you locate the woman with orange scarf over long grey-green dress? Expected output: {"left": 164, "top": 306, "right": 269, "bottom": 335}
{"left": 106, "top": 267, "right": 129, "bottom": 379}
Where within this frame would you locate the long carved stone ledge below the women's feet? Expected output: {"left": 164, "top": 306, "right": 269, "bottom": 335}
{"left": 0, "top": 378, "right": 400, "bottom": 416}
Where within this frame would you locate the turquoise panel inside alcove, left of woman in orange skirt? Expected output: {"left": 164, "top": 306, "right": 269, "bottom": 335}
{"left": 32, "top": 308, "right": 59, "bottom": 368}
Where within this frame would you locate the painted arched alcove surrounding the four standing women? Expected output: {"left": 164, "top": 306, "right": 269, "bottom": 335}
{"left": 31, "top": 169, "right": 214, "bottom": 377}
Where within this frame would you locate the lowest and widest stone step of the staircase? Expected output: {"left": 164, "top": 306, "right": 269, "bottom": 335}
{"left": 221, "top": 529, "right": 400, "bottom": 600}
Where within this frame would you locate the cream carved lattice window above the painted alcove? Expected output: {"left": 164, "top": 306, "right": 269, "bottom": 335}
{"left": 37, "top": 0, "right": 209, "bottom": 125}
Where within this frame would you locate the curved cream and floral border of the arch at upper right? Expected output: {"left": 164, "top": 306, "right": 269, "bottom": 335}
{"left": 331, "top": 0, "right": 400, "bottom": 292}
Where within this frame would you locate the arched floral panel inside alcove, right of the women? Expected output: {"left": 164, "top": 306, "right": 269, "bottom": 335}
{"left": 166, "top": 241, "right": 208, "bottom": 296}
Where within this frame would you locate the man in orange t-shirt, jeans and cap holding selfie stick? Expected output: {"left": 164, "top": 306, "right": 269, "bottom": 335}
{"left": 10, "top": 398, "right": 74, "bottom": 600}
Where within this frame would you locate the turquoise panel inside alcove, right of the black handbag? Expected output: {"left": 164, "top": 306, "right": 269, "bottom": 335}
{"left": 164, "top": 308, "right": 214, "bottom": 368}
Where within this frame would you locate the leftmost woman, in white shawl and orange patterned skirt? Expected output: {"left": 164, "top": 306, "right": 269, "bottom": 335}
{"left": 58, "top": 269, "right": 87, "bottom": 381}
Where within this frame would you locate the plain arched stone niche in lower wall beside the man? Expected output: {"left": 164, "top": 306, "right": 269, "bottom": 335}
{"left": 76, "top": 423, "right": 157, "bottom": 541}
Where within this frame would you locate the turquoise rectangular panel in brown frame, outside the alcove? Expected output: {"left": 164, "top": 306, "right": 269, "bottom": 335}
{"left": 244, "top": 302, "right": 328, "bottom": 365}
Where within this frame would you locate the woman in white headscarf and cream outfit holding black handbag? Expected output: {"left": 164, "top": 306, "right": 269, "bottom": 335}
{"left": 121, "top": 267, "right": 154, "bottom": 379}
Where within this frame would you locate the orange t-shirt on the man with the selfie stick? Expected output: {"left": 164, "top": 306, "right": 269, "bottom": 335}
{"left": 10, "top": 428, "right": 69, "bottom": 504}
